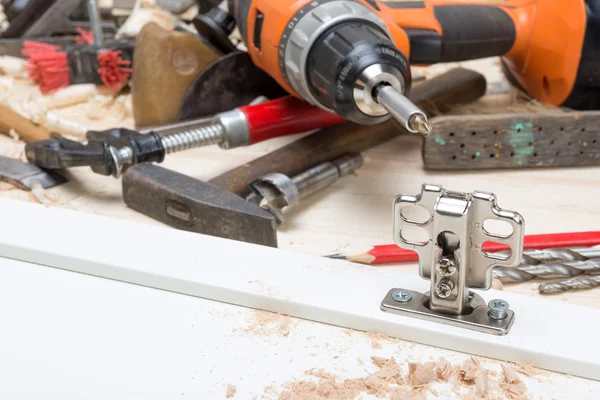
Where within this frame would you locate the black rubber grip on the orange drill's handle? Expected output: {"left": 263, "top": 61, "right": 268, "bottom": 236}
{"left": 434, "top": 5, "right": 516, "bottom": 62}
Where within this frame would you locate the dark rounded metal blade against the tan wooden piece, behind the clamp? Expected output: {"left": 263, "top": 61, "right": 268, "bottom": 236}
{"left": 178, "top": 52, "right": 287, "bottom": 121}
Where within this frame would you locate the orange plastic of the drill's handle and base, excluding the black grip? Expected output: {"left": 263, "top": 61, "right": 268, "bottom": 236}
{"left": 380, "top": 0, "right": 587, "bottom": 106}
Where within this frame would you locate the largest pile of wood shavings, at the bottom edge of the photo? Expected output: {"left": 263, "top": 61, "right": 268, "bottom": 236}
{"left": 279, "top": 357, "right": 529, "bottom": 400}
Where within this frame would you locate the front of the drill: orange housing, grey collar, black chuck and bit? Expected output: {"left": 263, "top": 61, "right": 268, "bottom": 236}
{"left": 230, "top": 0, "right": 428, "bottom": 134}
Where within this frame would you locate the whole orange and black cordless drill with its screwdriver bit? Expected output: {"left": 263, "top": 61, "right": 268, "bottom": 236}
{"left": 229, "top": 0, "right": 600, "bottom": 134}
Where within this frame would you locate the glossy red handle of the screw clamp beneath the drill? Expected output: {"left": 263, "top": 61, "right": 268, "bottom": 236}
{"left": 239, "top": 96, "right": 345, "bottom": 144}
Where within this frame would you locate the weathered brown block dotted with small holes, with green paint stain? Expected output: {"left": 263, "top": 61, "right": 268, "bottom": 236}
{"left": 423, "top": 111, "right": 600, "bottom": 170}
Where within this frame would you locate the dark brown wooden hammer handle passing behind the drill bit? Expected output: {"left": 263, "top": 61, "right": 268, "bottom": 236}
{"left": 210, "top": 68, "right": 486, "bottom": 197}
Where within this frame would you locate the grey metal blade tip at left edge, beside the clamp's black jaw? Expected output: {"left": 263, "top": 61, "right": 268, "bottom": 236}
{"left": 0, "top": 156, "right": 68, "bottom": 190}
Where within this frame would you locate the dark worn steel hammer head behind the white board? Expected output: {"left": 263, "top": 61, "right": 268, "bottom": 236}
{"left": 123, "top": 163, "right": 277, "bottom": 247}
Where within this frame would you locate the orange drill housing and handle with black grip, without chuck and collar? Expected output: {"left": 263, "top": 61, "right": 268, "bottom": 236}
{"left": 230, "top": 0, "right": 588, "bottom": 115}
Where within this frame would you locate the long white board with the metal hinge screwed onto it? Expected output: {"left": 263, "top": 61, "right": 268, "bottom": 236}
{"left": 0, "top": 201, "right": 600, "bottom": 379}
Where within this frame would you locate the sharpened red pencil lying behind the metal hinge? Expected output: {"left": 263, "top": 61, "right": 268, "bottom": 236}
{"left": 326, "top": 231, "right": 600, "bottom": 265}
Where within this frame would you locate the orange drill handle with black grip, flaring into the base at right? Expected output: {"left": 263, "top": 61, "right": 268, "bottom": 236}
{"left": 382, "top": 0, "right": 588, "bottom": 106}
